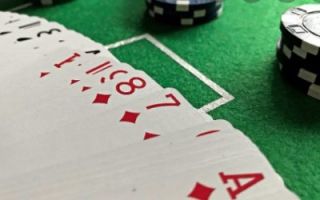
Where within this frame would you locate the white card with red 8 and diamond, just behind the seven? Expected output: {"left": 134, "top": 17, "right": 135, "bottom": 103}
{"left": 0, "top": 61, "right": 162, "bottom": 146}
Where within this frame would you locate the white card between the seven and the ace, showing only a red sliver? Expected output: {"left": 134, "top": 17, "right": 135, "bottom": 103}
{"left": 0, "top": 127, "right": 257, "bottom": 197}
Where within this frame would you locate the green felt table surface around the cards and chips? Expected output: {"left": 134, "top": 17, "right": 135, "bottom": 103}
{"left": 12, "top": 0, "right": 320, "bottom": 200}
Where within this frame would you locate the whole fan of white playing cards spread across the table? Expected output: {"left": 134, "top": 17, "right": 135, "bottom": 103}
{"left": 0, "top": 12, "right": 298, "bottom": 200}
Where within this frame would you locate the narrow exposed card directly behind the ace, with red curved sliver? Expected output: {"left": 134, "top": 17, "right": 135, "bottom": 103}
{"left": 0, "top": 122, "right": 256, "bottom": 198}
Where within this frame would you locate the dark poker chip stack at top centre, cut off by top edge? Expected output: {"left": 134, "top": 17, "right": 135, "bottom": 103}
{"left": 146, "top": 0, "right": 223, "bottom": 26}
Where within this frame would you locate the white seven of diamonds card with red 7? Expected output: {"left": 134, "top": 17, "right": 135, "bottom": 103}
{"left": 0, "top": 89, "right": 209, "bottom": 180}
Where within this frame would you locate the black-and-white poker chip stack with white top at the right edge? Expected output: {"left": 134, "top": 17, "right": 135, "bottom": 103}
{"left": 277, "top": 4, "right": 320, "bottom": 100}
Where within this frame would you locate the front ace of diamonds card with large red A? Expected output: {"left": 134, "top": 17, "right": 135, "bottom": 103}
{"left": 48, "top": 152, "right": 287, "bottom": 199}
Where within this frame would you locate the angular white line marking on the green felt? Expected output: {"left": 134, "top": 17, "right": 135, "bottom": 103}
{"left": 105, "top": 33, "right": 234, "bottom": 112}
